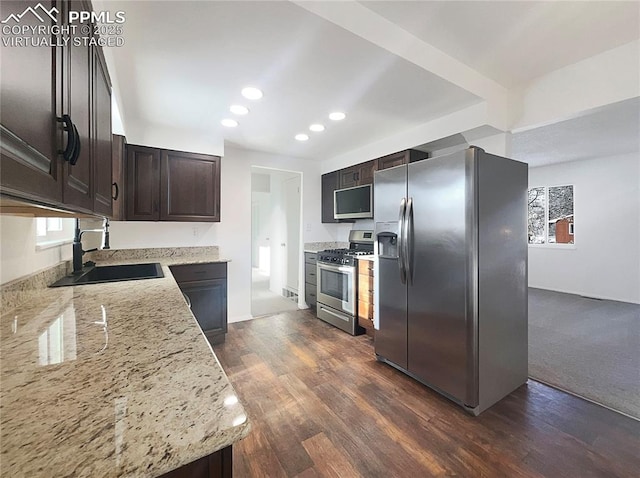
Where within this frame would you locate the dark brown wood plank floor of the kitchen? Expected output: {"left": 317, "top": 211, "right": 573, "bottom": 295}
{"left": 215, "top": 311, "right": 640, "bottom": 478}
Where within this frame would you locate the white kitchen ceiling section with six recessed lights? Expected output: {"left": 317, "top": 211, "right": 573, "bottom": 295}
{"left": 109, "top": 1, "right": 479, "bottom": 159}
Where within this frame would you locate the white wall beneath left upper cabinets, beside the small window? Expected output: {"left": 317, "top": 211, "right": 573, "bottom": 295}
{"left": 0, "top": 216, "right": 72, "bottom": 284}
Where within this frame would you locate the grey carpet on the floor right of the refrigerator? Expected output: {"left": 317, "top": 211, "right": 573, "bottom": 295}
{"left": 529, "top": 289, "right": 640, "bottom": 419}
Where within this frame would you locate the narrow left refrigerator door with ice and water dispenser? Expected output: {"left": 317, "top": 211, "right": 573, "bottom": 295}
{"left": 373, "top": 166, "right": 407, "bottom": 369}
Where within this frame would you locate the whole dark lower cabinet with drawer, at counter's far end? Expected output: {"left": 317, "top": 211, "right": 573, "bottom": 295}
{"left": 170, "top": 262, "right": 227, "bottom": 345}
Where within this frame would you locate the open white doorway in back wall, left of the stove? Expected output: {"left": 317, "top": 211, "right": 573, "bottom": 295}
{"left": 251, "top": 166, "right": 302, "bottom": 317}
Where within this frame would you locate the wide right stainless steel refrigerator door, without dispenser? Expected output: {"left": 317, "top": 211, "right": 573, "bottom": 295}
{"left": 407, "top": 149, "right": 477, "bottom": 406}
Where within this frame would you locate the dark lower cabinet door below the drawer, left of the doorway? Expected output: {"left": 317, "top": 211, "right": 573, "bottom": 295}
{"left": 180, "top": 279, "right": 227, "bottom": 343}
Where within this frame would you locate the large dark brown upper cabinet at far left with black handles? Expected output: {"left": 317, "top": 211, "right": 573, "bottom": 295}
{"left": 0, "top": 0, "right": 111, "bottom": 216}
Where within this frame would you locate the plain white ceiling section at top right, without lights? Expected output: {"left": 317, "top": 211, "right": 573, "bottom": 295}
{"left": 360, "top": 0, "right": 640, "bottom": 87}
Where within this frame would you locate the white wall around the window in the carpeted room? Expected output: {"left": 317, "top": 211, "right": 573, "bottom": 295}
{"left": 529, "top": 153, "right": 640, "bottom": 303}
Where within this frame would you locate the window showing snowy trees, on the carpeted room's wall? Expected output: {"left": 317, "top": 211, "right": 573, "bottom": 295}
{"left": 527, "top": 185, "right": 575, "bottom": 244}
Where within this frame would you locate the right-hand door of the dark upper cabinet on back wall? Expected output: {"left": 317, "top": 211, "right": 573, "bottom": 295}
{"left": 160, "top": 151, "right": 220, "bottom": 222}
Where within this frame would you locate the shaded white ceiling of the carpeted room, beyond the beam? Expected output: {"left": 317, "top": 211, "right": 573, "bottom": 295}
{"left": 512, "top": 98, "right": 640, "bottom": 167}
